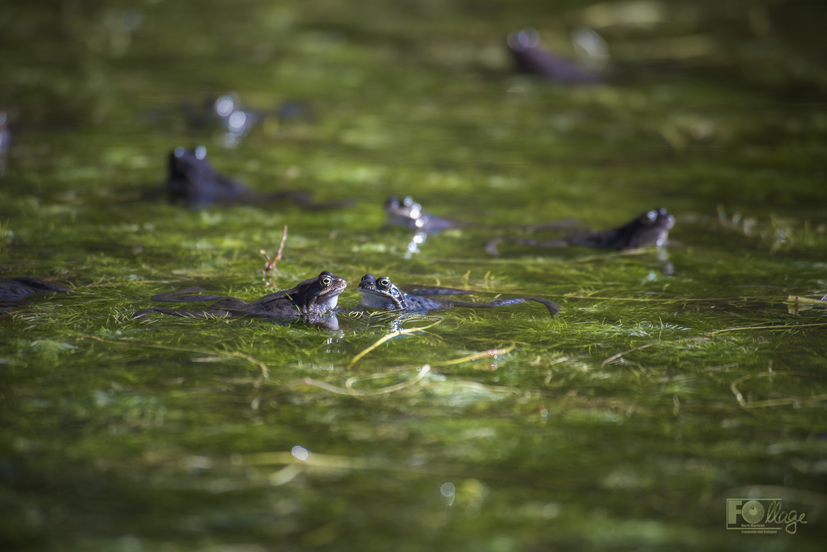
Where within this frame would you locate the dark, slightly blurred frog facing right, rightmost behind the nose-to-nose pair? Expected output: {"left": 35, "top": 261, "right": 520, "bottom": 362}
{"left": 485, "top": 207, "right": 675, "bottom": 255}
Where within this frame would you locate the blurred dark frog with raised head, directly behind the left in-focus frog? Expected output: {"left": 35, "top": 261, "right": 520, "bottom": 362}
{"left": 166, "top": 146, "right": 351, "bottom": 209}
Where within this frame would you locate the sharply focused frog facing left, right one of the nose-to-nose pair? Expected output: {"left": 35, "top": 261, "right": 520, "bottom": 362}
{"left": 358, "top": 274, "right": 560, "bottom": 317}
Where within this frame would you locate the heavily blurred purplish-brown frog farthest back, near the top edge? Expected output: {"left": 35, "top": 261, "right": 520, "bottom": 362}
{"left": 507, "top": 29, "right": 603, "bottom": 84}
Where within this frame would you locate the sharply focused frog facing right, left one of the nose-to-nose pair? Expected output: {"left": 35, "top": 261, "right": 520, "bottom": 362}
{"left": 134, "top": 271, "right": 347, "bottom": 329}
